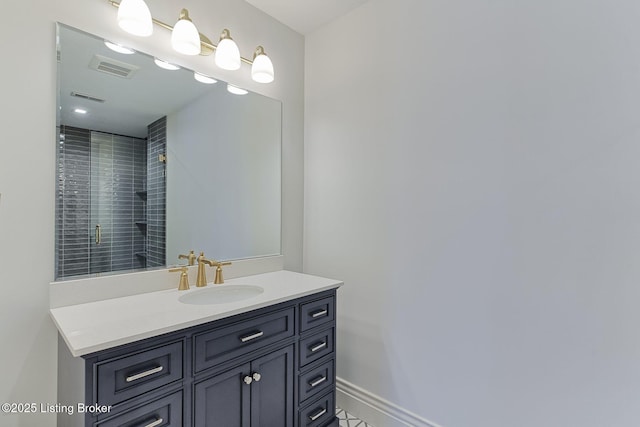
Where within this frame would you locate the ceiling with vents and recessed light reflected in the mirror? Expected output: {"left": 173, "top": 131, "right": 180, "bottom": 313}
{"left": 58, "top": 25, "right": 232, "bottom": 138}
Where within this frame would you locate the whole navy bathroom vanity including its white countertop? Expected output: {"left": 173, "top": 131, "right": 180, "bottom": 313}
{"left": 51, "top": 271, "right": 341, "bottom": 427}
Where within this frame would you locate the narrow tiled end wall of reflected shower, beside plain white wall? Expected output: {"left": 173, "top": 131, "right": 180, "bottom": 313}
{"left": 147, "top": 117, "right": 167, "bottom": 267}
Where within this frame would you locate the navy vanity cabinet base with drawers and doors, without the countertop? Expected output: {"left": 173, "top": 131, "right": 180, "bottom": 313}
{"left": 58, "top": 289, "right": 338, "bottom": 427}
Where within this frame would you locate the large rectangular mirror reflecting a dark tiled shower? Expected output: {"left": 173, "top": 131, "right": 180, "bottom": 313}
{"left": 56, "top": 24, "right": 281, "bottom": 279}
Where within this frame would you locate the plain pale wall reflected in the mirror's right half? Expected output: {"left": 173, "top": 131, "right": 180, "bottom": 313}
{"left": 167, "top": 84, "right": 282, "bottom": 264}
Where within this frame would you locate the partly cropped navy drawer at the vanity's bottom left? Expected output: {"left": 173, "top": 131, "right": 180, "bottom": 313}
{"left": 96, "top": 391, "right": 182, "bottom": 427}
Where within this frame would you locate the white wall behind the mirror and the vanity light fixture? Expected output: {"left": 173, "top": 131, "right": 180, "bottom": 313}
{"left": 0, "top": 0, "right": 304, "bottom": 427}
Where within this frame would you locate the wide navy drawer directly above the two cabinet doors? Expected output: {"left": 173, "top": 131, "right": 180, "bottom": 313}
{"left": 193, "top": 307, "right": 294, "bottom": 372}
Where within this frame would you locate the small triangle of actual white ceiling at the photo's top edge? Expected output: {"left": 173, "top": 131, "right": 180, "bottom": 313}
{"left": 245, "top": 0, "right": 368, "bottom": 35}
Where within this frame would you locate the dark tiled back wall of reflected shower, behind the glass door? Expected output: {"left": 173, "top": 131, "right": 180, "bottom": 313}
{"left": 56, "top": 126, "right": 147, "bottom": 278}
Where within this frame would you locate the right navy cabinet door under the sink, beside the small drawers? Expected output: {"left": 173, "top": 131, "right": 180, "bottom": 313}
{"left": 251, "top": 345, "right": 294, "bottom": 427}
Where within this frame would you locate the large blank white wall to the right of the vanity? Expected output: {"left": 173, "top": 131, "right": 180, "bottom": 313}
{"left": 304, "top": 0, "right": 640, "bottom": 427}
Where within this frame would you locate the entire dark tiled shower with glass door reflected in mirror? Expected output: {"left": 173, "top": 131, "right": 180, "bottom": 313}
{"left": 56, "top": 118, "right": 166, "bottom": 278}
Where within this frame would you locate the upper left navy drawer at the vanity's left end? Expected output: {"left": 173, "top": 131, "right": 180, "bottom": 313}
{"left": 95, "top": 341, "right": 184, "bottom": 405}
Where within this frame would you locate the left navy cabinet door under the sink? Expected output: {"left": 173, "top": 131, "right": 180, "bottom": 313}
{"left": 193, "top": 363, "right": 251, "bottom": 427}
